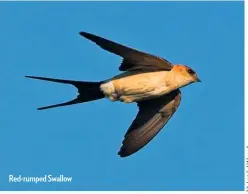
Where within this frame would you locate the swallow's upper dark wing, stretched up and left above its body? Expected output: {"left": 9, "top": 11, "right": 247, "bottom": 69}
{"left": 80, "top": 32, "right": 172, "bottom": 71}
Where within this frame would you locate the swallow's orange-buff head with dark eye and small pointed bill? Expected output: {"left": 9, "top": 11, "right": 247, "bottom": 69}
{"left": 172, "top": 65, "right": 201, "bottom": 86}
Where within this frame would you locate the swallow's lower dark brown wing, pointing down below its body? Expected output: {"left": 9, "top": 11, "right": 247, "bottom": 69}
{"left": 118, "top": 90, "right": 181, "bottom": 157}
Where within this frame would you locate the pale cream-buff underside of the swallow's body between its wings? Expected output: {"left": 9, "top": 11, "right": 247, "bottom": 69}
{"left": 100, "top": 71, "right": 183, "bottom": 103}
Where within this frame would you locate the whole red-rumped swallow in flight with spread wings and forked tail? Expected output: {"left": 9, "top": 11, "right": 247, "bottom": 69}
{"left": 25, "top": 32, "right": 200, "bottom": 157}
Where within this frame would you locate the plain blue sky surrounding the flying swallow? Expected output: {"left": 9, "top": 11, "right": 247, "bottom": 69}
{"left": 0, "top": 2, "right": 244, "bottom": 190}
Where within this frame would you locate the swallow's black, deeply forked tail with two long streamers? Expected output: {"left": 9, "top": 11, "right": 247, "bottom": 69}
{"left": 25, "top": 76, "right": 104, "bottom": 110}
